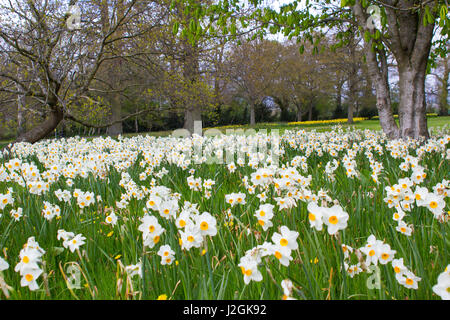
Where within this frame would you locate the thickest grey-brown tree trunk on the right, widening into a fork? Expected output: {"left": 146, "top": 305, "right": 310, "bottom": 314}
{"left": 386, "top": 0, "right": 437, "bottom": 139}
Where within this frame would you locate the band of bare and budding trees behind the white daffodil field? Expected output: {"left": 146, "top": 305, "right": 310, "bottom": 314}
{"left": 0, "top": 0, "right": 449, "bottom": 142}
